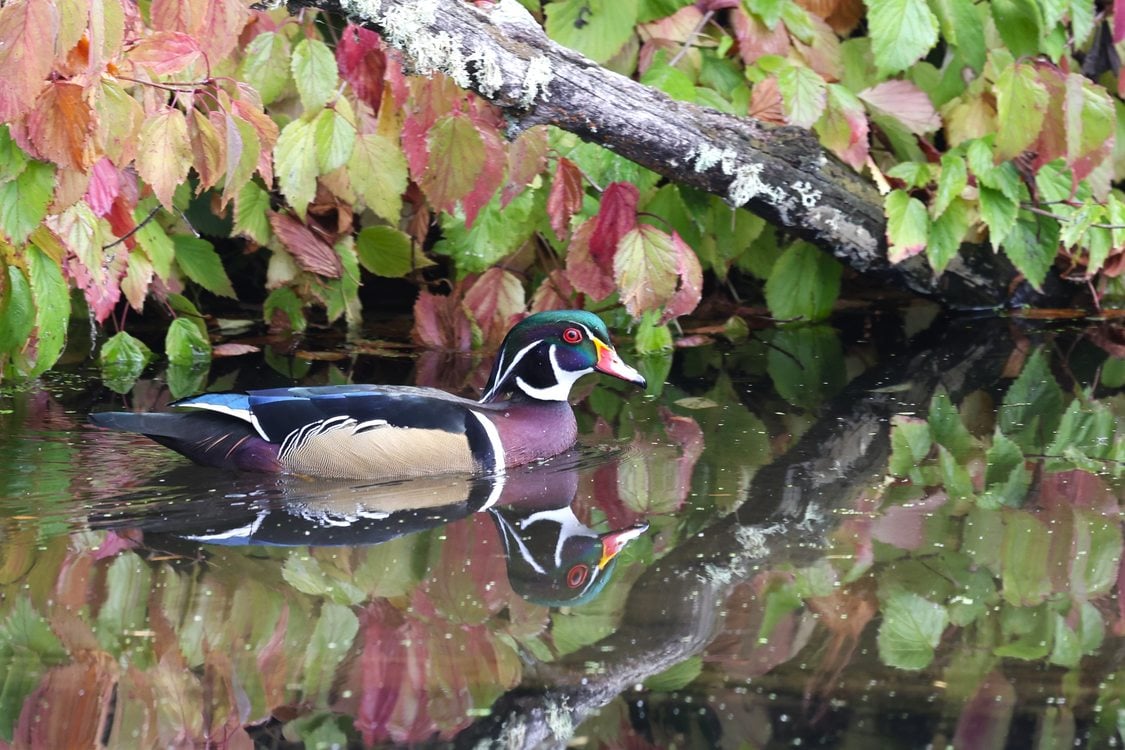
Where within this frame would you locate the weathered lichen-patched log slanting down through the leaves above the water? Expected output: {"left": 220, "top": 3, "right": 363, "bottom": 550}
{"left": 289, "top": 0, "right": 1062, "bottom": 308}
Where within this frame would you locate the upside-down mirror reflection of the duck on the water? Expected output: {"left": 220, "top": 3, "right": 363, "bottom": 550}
{"left": 90, "top": 452, "right": 648, "bottom": 606}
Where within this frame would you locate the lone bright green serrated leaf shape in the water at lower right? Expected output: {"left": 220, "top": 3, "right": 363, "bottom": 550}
{"left": 878, "top": 590, "right": 948, "bottom": 670}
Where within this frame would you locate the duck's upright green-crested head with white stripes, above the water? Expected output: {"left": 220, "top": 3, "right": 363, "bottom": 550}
{"left": 480, "top": 310, "right": 646, "bottom": 401}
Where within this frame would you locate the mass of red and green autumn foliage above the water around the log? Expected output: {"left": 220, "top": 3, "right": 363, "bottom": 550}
{"left": 0, "top": 0, "right": 1125, "bottom": 376}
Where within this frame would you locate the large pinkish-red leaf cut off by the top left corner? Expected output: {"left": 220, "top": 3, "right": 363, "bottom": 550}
{"left": 0, "top": 0, "right": 59, "bottom": 123}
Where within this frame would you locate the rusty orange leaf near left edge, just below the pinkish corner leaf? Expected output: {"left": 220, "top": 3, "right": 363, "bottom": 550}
{"left": 27, "top": 81, "right": 95, "bottom": 172}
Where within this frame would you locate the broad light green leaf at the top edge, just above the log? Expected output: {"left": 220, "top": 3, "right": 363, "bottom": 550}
{"left": 547, "top": 0, "right": 637, "bottom": 64}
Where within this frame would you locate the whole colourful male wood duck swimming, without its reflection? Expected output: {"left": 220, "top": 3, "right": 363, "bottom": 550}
{"left": 90, "top": 310, "right": 646, "bottom": 479}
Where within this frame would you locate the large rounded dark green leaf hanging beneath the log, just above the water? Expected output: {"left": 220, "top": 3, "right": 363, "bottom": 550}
{"left": 766, "top": 241, "right": 843, "bottom": 322}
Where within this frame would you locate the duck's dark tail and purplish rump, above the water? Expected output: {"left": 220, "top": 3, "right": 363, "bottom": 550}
{"left": 89, "top": 412, "right": 281, "bottom": 472}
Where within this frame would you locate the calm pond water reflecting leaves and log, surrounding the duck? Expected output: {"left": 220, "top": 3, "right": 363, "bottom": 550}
{"left": 0, "top": 315, "right": 1125, "bottom": 749}
